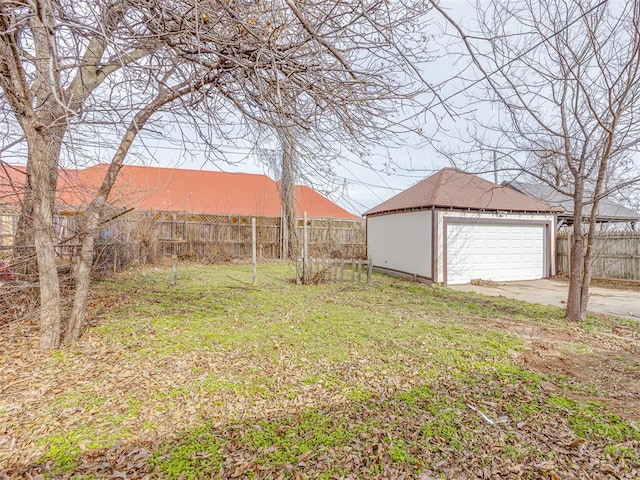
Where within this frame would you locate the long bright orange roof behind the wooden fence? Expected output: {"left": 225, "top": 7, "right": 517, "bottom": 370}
{"left": 0, "top": 164, "right": 359, "bottom": 219}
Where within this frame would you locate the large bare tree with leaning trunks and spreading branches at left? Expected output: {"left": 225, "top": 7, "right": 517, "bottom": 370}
{"left": 0, "top": 0, "right": 436, "bottom": 347}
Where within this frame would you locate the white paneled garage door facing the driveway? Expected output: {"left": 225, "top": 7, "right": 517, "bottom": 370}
{"left": 446, "top": 223, "right": 546, "bottom": 284}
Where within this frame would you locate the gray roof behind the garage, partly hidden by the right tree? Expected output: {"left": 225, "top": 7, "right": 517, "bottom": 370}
{"left": 505, "top": 182, "right": 640, "bottom": 222}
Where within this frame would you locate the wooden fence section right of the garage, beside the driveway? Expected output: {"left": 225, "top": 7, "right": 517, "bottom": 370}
{"left": 556, "top": 232, "right": 640, "bottom": 281}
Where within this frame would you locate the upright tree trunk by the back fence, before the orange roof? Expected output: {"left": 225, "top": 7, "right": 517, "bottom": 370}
{"left": 280, "top": 128, "right": 298, "bottom": 258}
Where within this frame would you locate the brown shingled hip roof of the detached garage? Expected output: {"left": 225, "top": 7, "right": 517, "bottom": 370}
{"left": 364, "top": 168, "right": 557, "bottom": 215}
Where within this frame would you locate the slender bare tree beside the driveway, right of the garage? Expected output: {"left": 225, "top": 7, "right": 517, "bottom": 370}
{"left": 434, "top": 0, "right": 640, "bottom": 321}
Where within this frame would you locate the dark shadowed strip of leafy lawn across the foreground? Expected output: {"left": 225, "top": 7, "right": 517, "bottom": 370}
{"left": 4, "top": 364, "right": 640, "bottom": 479}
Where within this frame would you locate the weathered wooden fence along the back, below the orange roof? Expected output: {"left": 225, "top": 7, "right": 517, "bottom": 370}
{"left": 0, "top": 211, "right": 366, "bottom": 263}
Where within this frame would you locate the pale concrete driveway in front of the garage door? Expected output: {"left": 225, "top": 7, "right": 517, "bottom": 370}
{"left": 449, "top": 279, "right": 640, "bottom": 320}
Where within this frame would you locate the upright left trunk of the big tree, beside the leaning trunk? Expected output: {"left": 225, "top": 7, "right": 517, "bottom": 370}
{"left": 29, "top": 135, "right": 60, "bottom": 348}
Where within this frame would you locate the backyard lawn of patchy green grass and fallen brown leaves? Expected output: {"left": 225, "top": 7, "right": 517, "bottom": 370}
{"left": 0, "top": 264, "right": 640, "bottom": 479}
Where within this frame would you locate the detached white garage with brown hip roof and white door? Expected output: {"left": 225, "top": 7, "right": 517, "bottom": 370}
{"left": 365, "top": 168, "right": 556, "bottom": 285}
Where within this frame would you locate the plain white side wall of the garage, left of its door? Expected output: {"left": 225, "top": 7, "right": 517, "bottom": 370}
{"left": 367, "top": 210, "right": 432, "bottom": 278}
